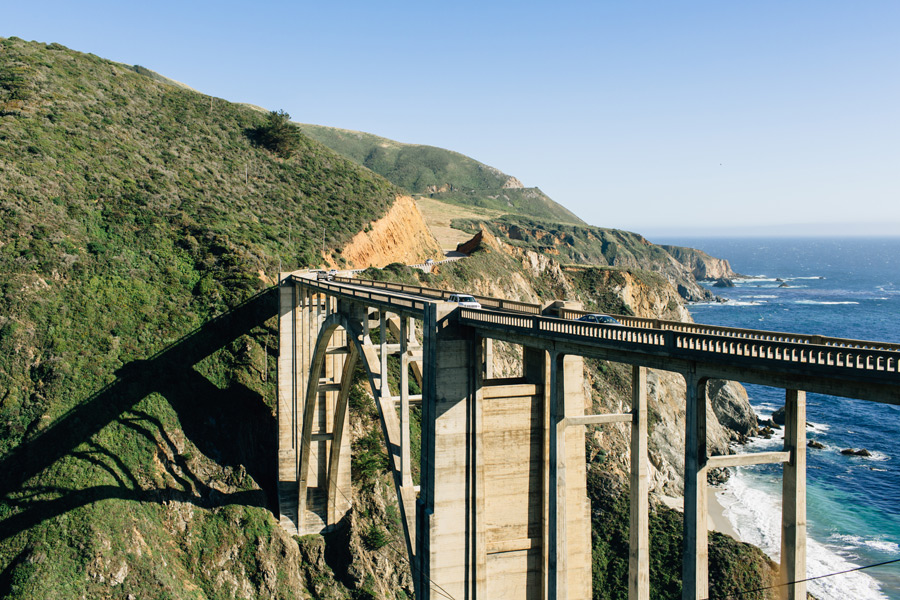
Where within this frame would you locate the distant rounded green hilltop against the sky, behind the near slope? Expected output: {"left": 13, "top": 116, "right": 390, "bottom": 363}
{"left": 299, "top": 124, "right": 584, "bottom": 224}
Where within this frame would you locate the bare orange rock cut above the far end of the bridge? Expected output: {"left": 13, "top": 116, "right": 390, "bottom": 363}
{"left": 342, "top": 196, "right": 444, "bottom": 269}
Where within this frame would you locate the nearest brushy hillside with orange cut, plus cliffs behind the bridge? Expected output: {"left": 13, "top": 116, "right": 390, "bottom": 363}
{"left": 0, "top": 38, "right": 771, "bottom": 600}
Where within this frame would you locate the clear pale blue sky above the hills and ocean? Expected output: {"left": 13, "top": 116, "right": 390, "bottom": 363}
{"left": 0, "top": 0, "right": 900, "bottom": 235}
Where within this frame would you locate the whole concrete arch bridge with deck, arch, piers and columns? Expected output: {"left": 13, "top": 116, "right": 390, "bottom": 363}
{"left": 278, "top": 272, "right": 900, "bottom": 600}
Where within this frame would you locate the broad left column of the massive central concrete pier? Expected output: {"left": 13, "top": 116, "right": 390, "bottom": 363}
{"left": 416, "top": 303, "right": 487, "bottom": 600}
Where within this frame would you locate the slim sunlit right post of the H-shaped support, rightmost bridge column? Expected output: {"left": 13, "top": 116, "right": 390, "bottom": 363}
{"left": 779, "top": 390, "right": 806, "bottom": 600}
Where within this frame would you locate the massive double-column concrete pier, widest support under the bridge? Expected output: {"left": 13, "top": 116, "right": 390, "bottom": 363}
{"left": 417, "top": 303, "right": 591, "bottom": 600}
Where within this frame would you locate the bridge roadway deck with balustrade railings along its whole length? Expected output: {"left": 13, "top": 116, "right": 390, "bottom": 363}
{"left": 294, "top": 276, "right": 900, "bottom": 404}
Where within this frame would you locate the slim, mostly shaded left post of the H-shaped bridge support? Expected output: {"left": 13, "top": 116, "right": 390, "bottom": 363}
{"left": 681, "top": 373, "right": 709, "bottom": 600}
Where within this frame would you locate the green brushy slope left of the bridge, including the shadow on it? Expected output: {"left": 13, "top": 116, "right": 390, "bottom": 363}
{"left": 0, "top": 38, "right": 397, "bottom": 598}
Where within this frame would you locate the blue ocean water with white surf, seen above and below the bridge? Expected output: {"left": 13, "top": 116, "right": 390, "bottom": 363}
{"left": 653, "top": 238, "right": 900, "bottom": 600}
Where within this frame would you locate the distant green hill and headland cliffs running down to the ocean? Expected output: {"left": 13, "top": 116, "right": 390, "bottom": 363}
{"left": 298, "top": 124, "right": 735, "bottom": 301}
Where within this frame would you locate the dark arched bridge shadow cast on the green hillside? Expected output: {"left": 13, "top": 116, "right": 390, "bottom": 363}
{"left": 0, "top": 287, "right": 278, "bottom": 544}
